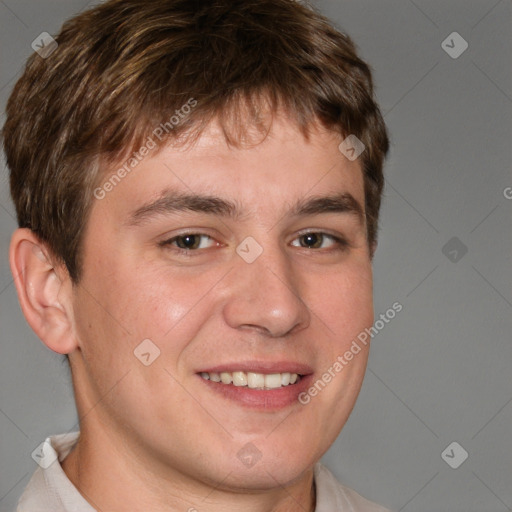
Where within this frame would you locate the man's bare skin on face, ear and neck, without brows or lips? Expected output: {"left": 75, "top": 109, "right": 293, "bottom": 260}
{"left": 10, "top": 116, "right": 373, "bottom": 512}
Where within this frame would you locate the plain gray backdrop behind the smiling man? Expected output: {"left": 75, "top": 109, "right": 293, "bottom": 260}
{"left": 0, "top": 0, "right": 512, "bottom": 512}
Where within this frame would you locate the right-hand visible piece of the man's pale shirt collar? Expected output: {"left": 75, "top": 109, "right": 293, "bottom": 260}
{"left": 315, "top": 463, "right": 390, "bottom": 512}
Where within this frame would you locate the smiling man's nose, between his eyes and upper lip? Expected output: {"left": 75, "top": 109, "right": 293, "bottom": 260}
{"left": 223, "top": 241, "right": 311, "bottom": 338}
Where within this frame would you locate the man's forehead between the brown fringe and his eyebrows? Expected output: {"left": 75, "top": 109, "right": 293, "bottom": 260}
{"left": 93, "top": 116, "right": 364, "bottom": 224}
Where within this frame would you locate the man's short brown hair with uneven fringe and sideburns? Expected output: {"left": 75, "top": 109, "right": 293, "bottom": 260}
{"left": 3, "top": 0, "right": 388, "bottom": 283}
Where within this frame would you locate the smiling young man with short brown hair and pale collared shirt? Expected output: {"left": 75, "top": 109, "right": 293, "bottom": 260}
{"left": 3, "top": 0, "right": 388, "bottom": 512}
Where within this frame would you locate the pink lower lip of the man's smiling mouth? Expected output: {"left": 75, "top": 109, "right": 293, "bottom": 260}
{"left": 198, "top": 374, "right": 313, "bottom": 411}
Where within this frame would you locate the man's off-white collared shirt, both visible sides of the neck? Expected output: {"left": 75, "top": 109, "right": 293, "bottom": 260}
{"left": 17, "top": 432, "right": 390, "bottom": 512}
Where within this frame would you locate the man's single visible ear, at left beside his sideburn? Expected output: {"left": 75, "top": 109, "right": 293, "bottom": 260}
{"left": 9, "top": 228, "right": 78, "bottom": 354}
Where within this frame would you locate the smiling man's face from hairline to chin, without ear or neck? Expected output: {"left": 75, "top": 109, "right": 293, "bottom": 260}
{"left": 70, "top": 118, "right": 373, "bottom": 490}
